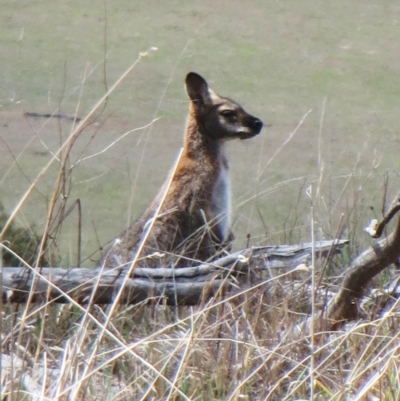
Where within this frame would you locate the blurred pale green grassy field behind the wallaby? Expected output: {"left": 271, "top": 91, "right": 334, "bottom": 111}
{"left": 0, "top": 0, "right": 400, "bottom": 264}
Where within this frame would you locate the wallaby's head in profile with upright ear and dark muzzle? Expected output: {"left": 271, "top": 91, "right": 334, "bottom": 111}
{"left": 186, "top": 72, "right": 263, "bottom": 140}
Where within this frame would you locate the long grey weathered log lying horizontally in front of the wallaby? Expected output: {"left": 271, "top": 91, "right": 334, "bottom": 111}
{"left": 3, "top": 240, "right": 348, "bottom": 305}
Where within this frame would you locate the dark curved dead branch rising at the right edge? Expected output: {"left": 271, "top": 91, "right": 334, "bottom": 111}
{"left": 322, "top": 198, "right": 400, "bottom": 330}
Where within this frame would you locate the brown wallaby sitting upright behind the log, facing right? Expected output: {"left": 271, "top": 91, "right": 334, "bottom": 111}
{"left": 103, "top": 72, "right": 263, "bottom": 267}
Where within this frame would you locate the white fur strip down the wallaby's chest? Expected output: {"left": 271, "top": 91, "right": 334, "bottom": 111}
{"left": 211, "top": 157, "right": 231, "bottom": 241}
